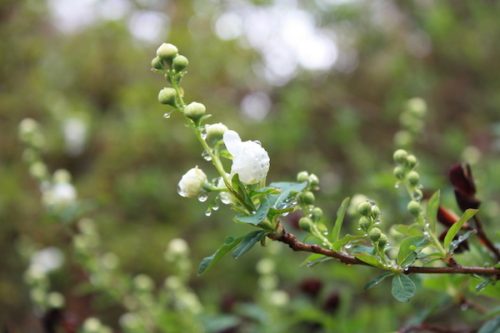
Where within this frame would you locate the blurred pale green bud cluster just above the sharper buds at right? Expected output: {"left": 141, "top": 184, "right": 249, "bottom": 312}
{"left": 394, "top": 97, "right": 427, "bottom": 147}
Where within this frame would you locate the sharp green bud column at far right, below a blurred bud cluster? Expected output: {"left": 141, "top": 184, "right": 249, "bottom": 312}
{"left": 393, "top": 149, "right": 423, "bottom": 217}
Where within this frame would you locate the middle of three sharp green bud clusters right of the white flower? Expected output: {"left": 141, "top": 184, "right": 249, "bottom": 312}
{"left": 358, "top": 200, "right": 387, "bottom": 251}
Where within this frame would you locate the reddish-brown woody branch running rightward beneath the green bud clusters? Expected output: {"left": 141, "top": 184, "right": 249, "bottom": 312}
{"left": 269, "top": 225, "right": 500, "bottom": 278}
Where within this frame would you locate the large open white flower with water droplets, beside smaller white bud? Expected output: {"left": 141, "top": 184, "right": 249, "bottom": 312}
{"left": 223, "top": 130, "right": 269, "bottom": 184}
